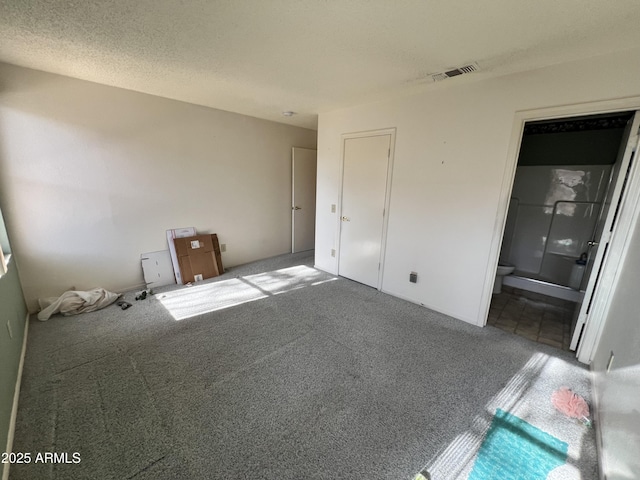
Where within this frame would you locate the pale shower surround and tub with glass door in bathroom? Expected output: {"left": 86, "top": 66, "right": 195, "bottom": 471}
{"left": 500, "top": 165, "right": 612, "bottom": 301}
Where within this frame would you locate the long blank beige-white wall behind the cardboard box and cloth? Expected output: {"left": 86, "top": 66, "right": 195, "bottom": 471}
{"left": 0, "top": 64, "right": 316, "bottom": 308}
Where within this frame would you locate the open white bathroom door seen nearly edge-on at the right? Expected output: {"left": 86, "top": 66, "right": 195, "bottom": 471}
{"left": 569, "top": 113, "right": 640, "bottom": 350}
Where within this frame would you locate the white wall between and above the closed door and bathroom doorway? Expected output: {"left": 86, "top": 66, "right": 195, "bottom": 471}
{"left": 316, "top": 50, "right": 640, "bottom": 325}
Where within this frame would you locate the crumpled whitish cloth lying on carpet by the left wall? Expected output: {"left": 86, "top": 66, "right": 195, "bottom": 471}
{"left": 38, "top": 288, "right": 120, "bottom": 322}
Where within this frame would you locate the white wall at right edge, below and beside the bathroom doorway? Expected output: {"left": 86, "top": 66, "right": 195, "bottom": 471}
{"left": 591, "top": 216, "right": 640, "bottom": 480}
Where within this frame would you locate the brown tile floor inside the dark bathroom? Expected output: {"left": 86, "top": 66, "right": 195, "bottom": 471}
{"left": 487, "top": 287, "right": 575, "bottom": 350}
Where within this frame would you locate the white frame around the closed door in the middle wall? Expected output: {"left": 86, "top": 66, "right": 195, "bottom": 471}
{"left": 334, "top": 127, "right": 396, "bottom": 290}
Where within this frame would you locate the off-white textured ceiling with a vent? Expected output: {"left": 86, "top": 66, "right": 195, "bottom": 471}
{"left": 0, "top": 0, "right": 640, "bottom": 128}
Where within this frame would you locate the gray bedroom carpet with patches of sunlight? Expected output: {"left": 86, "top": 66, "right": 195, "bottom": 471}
{"left": 10, "top": 254, "right": 597, "bottom": 480}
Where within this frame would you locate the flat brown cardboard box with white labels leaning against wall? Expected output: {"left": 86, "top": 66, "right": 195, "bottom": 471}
{"left": 173, "top": 235, "right": 220, "bottom": 283}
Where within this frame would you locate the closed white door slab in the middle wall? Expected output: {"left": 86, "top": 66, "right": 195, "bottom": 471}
{"left": 338, "top": 134, "right": 391, "bottom": 288}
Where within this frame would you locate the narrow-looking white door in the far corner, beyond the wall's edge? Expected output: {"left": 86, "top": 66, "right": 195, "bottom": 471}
{"left": 291, "top": 147, "right": 317, "bottom": 253}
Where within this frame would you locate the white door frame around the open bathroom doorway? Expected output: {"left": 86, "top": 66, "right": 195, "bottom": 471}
{"left": 478, "top": 97, "right": 640, "bottom": 364}
